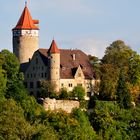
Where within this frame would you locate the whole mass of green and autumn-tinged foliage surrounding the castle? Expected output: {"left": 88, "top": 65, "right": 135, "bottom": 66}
{"left": 0, "top": 40, "right": 140, "bottom": 140}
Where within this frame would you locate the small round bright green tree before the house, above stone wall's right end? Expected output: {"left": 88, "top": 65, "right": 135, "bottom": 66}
{"left": 72, "top": 86, "right": 85, "bottom": 100}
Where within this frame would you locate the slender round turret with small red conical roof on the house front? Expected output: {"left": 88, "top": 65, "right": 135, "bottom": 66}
{"left": 47, "top": 40, "right": 60, "bottom": 91}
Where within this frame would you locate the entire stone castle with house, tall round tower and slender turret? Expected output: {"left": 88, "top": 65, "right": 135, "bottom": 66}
{"left": 12, "top": 3, "right": 96, "bottom": 97}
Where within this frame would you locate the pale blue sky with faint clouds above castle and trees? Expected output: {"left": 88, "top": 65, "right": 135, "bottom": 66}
{"left": 0, "top": 0, "right": 140, "bottom": 58}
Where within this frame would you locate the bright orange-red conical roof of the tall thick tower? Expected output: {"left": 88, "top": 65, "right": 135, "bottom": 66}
{"left": 14, "top": 5, "right": 39, "bottom": 30}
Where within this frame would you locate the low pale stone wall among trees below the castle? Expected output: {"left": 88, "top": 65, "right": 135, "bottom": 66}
{"left": 43, "top": 98, "right": 80, "bottom": 113}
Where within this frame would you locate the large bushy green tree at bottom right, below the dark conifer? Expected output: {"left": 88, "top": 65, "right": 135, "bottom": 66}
{"left": 90, "top": 101, "right": 132, "bottom": 140}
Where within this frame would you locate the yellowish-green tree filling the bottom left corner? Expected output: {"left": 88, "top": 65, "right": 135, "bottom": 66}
{"left": 0, "top": 99, "right": 32, "bottom": 140}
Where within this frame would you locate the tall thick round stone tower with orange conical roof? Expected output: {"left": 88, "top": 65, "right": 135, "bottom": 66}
{"left": 12, "top": 4, "right": 39, "bottom": 64}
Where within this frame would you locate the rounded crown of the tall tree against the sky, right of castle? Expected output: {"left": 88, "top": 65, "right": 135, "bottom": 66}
{"left": 101, "top": 40, "right": 136, "bottom": 68}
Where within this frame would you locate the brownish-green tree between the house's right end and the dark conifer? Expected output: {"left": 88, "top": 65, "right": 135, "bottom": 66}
{"left": 99, "top": 64, "right": 119, "bottom": 100}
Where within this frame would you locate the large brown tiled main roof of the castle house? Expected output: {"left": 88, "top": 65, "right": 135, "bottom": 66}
{"left": 38, "top": 49, "right": 94, "bottom": 79}
